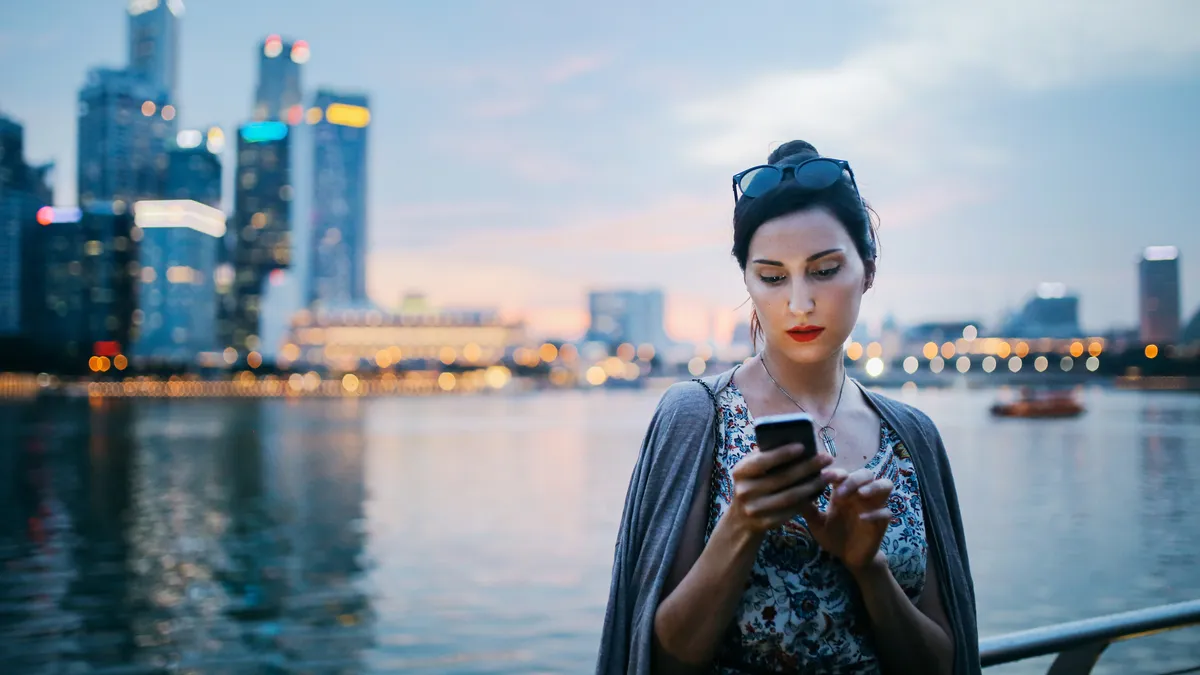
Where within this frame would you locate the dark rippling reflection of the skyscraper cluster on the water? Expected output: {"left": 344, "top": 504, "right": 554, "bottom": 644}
{"left": 0, "top": 400, "right": 372, "bottom": 673}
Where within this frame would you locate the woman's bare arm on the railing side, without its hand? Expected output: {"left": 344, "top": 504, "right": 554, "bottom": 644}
{"left": 854, "top": 552, "right": 954, "bottom": 675}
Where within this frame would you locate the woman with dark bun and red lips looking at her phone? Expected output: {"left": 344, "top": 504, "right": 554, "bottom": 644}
{"left": 596, "top": 141, "right": 979, "bottom": 675}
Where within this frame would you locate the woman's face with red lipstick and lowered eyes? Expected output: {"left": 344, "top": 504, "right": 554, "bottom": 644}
{"left": 745, "top": 208, "right": 866, "bottom": 363}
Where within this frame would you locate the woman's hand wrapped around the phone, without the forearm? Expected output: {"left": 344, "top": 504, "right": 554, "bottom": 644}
{"left": 727, "top": 443, "right": 846, "bottom": 534}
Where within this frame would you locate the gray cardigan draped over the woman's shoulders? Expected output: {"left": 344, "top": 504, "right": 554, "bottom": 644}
{"left": 596, "top": 369, "right": 980, "bottom": 675}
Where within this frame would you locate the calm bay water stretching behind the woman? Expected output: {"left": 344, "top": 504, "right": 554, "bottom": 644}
{"left": 0, "top": 389, "right": 1200, "bottom": 674}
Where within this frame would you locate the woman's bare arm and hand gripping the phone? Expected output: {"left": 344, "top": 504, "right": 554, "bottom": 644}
{"left": 654, "top": 446, "right": 830, "bottom": 674}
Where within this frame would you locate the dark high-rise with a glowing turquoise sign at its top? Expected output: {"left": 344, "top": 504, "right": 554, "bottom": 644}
{"left": 221, "top": 121, "right": 295, "bottom": 351}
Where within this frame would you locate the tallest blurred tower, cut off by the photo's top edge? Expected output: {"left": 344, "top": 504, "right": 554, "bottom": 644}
{"left": 128, "top": 0, "right": 184, "bottom": 106}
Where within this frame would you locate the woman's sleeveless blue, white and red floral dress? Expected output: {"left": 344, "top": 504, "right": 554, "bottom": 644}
{"left": 704, "top": 384, "right": 929, "bottom": 675}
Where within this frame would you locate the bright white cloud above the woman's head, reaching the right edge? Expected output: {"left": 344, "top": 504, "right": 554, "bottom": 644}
{"left": 677, "top": 0, "right": 1200, "bottom": 169}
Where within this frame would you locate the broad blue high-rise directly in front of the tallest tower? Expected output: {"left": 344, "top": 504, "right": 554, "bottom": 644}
{"left": 78, "top": 68, "right": 175, "bottom": 209}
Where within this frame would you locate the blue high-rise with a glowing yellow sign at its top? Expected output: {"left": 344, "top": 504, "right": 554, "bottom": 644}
{"left": 305, "top": 90, "right": 371, "bottom": 307}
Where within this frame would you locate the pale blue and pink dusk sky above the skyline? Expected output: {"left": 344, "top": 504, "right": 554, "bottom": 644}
{"left": 0, "top": 0, "right": 1200, "bottom": 342}
